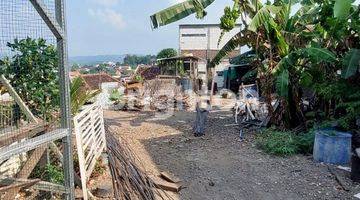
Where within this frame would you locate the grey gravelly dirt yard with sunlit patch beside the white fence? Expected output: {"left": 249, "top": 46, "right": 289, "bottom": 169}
{"left": 105, "top": 105, "right": 360, "bottom": 200}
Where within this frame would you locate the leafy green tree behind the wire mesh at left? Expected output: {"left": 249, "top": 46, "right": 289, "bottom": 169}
{"left": 0, "top": 38, "right": 60, "bottom": 117}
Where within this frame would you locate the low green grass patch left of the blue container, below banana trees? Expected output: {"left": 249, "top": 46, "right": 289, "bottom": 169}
{"left": 255, "top": 128, "right": 315, "bottom": 156}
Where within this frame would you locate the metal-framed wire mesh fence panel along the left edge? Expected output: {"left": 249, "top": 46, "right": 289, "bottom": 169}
{"left": 0, "top": 0, "right": 73, "bottom": 199}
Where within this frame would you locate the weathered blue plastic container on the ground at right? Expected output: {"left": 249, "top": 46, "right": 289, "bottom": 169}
{"left": 313, "top": 128, "right": 352, "bottom": 165}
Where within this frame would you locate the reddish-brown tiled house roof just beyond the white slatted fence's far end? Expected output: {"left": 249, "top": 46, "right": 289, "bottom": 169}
{"left": 81, "top": 73, "right": 120, "bottom": 90}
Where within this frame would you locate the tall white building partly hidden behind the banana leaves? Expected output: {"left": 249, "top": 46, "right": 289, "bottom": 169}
{"left": 179, "top": 24, "right": 241, "bottom": 88}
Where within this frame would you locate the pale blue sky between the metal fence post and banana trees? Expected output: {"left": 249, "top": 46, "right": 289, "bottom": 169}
{"left": 67, "top": 0, "right": 232, "bottom": 56}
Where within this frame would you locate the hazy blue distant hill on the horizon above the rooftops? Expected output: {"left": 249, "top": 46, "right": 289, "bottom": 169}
{"left": 69, "top": 55, "right": 125, "bottom": 65}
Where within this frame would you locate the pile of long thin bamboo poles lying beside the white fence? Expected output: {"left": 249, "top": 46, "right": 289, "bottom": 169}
{"left": 106, "top": 126, "right": 171, "bottom": 200}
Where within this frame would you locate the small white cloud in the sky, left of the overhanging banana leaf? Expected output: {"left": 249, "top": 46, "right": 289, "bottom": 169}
{"left": 88, "top": 8, "right": 126, "bottom": 30}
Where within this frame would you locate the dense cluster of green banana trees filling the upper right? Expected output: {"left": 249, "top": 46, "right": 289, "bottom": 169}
{"left": 151, "top": 0, "right": 360, "bottom": 127}
